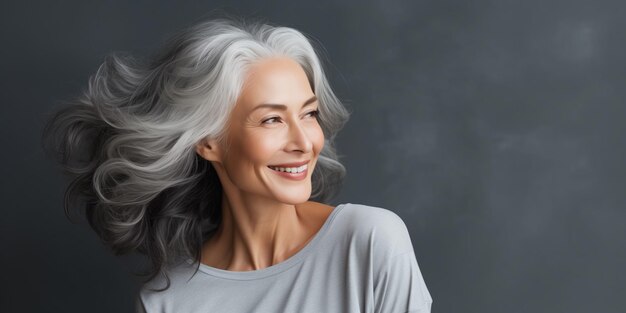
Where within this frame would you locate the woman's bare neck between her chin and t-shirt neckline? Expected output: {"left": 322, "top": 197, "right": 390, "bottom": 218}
{"left": 203, "top": 194, "right": 313, "bottom": 271}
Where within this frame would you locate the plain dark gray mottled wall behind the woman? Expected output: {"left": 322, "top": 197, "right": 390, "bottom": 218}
{"left": 0, "top": 0, "right": 626, "bottom": 313}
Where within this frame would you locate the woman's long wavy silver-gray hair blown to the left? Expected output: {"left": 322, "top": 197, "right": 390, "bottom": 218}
{"left": 42, "top": 17, "right": 350, "bottom": 290}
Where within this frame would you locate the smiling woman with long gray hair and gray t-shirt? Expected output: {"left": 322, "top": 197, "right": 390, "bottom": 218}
{"left": 46, "top": 14, "right": 432, "bottom": 312}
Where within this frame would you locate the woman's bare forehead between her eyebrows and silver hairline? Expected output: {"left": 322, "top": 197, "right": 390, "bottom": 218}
{"left": 238, "top": 57, "right": 313, "bottom": 109}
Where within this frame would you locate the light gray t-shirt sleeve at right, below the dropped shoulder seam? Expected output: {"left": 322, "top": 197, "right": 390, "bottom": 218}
{"left": 374, "top": 250, "right": 433, "bottom": 313}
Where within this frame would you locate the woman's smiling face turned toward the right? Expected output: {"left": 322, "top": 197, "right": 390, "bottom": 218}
{"left": 199, "top": 58, "right": 324, "bottom": 204}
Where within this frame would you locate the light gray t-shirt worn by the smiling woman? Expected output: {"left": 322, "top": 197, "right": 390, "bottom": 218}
{"left": 137, "top": 203, "right": 432, "bottom": 313}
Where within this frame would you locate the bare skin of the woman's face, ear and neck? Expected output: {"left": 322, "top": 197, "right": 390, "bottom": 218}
{"left": 196, "top": 57, "right": 333, "bottom": 271}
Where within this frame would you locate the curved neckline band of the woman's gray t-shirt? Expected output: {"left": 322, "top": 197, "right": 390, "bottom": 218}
{"left": 187, "top": 203, "right": 349, "bottom": 280}
